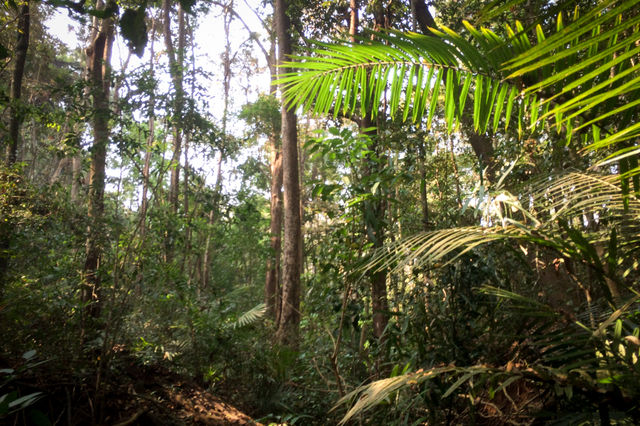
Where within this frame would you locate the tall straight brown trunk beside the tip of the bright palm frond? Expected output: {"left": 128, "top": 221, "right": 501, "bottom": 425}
{"left": 275, "top": 0, "right": 302, "bottom": 348}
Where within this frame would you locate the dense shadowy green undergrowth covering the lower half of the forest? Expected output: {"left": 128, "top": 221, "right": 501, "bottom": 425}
{"left": 0, "top": 164, "right": 640, "bottom": 424}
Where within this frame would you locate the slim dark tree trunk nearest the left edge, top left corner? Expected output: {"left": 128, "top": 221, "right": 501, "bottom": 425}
{"left": 7, "top": 1, "right": 31, "bottom": 166}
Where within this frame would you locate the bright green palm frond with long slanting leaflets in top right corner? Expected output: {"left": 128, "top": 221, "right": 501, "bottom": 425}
{"left": 503, "top": 0, "right": 640, "bottom": 160}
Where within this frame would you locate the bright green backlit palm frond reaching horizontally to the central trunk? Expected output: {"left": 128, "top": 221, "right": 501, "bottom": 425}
{"left": 278, "top": 25, "right": 519, "bottom": 131}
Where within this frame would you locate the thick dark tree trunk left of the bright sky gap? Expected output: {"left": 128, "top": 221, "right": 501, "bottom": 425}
{"left": 81, "top": 1, "right": 113, "bottom": 317}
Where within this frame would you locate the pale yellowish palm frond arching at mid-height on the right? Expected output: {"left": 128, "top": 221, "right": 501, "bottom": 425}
{"left": 365, "top": 172, "right": 640, "bottom": 271}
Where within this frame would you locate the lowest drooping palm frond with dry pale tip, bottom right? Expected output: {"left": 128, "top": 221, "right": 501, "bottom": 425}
{"left": 333, "top": 292, "right": 640, "bottom": 424}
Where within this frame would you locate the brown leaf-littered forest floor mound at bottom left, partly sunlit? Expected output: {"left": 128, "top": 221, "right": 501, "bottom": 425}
{"left": 0, "top": 354, "right": 261, "bottom": 426}
